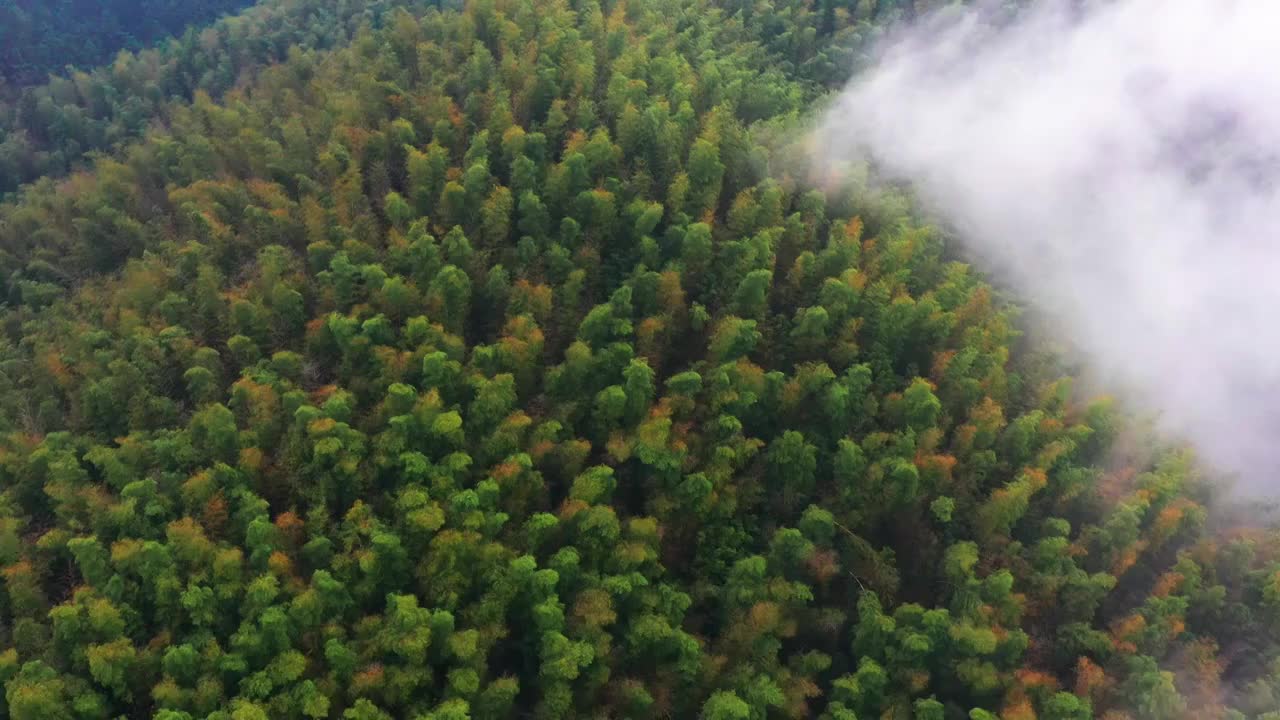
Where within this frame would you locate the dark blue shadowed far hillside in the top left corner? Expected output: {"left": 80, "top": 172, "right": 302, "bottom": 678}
{"left": 0, "top": 0, "right": 257, "bottom": 85}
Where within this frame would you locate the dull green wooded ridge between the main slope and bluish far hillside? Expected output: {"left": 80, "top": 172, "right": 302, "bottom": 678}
{"left": 0, "top": 0, "right": 468, "bottom": 196}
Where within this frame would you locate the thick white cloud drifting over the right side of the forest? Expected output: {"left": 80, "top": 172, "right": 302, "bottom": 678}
{"left": 819, "top": 0, "right": 1280, "bottom": 493}
